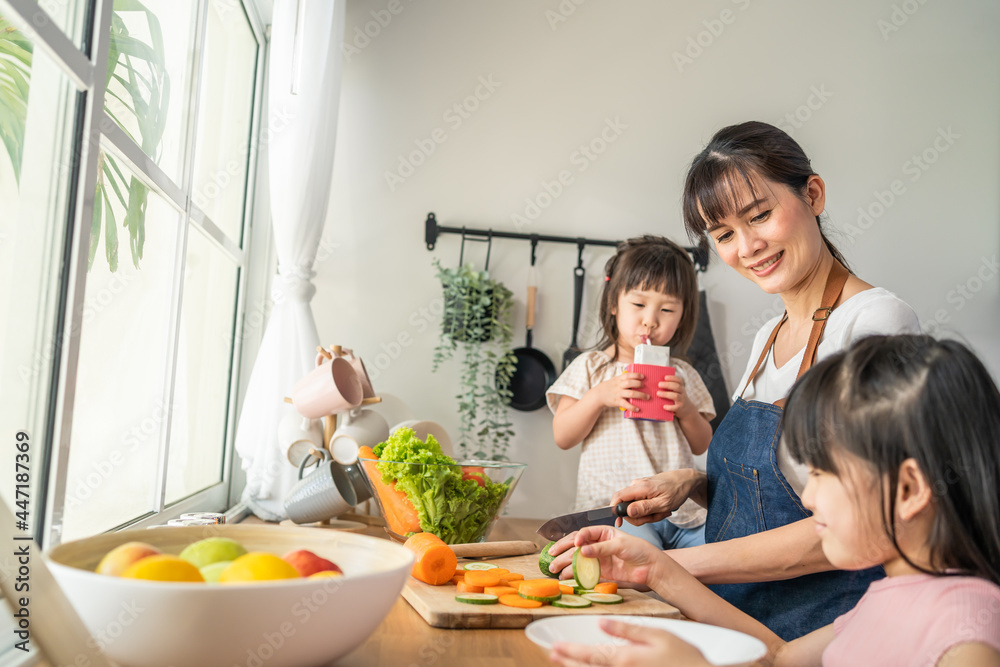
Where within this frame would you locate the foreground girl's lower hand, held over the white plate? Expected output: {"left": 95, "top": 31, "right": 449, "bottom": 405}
{"left": 549, "top": 619, "right": 711, "bottom": 667}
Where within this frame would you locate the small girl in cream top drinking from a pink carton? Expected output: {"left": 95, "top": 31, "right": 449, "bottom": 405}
{"left": 546, "top": 236, "right": 715, "bottom": 548}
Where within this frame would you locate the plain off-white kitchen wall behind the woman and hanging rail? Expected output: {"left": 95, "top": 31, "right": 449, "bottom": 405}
{"left": 313, "top": 0, "right": 1000, "bottom": 517}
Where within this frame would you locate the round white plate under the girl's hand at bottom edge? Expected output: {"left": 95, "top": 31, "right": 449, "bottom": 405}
{"left": 524, "top": 615, "right": 767, "bottom": 665}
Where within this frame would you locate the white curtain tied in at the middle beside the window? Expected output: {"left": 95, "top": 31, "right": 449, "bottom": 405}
{"left": 236, "top": 0, "right": 346, "bottom": 521}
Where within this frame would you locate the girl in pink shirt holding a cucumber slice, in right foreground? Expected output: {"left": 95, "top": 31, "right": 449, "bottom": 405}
{"left": 552, "top": 336, "right": 1000, "bottom": 667}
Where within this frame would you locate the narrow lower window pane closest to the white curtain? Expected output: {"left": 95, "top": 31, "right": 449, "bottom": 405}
{"left": 167, "top": 227, "right": 239, "bottom": 503}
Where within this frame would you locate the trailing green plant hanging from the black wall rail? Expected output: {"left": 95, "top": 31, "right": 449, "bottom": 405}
{"left": 434, "top": 260, "right": 516, "bottom": 461}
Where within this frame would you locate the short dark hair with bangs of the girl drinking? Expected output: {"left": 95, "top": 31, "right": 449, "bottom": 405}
{"left": 595, "top": 234, "right": 698, "bottom": 359}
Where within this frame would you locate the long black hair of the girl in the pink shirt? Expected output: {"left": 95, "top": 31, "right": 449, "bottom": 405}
{"left": 782, "top": 336, "right": 1000, "bottom": 584}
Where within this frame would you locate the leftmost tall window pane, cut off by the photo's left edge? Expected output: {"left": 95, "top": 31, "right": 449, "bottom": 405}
{"left": 0, "top": 17, "right": 78, "bottom": 544}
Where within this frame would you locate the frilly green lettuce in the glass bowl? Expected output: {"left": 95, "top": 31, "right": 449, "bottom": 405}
{"left": 374, "top": 428, "right": 510, "bottom": 544}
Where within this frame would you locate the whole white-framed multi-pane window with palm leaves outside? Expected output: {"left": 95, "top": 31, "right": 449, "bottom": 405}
{"left": 0, "top": 0, "right": 264, "bottom": 560}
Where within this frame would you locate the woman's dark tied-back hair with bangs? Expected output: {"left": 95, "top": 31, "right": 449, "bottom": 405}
{"left": 684, "top": 121, "right": 850, "bottom": 269}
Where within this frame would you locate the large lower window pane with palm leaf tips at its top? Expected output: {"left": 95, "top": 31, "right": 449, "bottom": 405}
{"left": 63, "top": 154, "right": 180, "bottom": 540}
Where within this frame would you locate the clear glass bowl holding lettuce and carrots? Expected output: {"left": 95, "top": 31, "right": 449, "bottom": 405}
{"left": 358, "top": 458, "right": 527, "bottom": 544}
